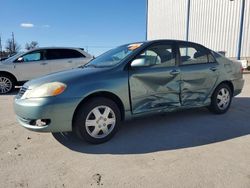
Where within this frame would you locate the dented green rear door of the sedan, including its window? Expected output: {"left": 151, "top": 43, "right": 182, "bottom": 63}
{"left": 179, "top": 43, "right": 218, "bottom": 107}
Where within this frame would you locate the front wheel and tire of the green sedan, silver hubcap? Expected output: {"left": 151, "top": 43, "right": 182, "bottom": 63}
{"left": 73, "top": 97, "right": 121, "bottom": 144}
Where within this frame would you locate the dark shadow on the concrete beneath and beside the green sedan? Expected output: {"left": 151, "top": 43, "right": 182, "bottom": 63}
{"left": 53, "top": 98, "right": 250, "bottom": 154}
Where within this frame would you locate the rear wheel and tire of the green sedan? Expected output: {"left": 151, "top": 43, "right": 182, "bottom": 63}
{"left": 208, "top": 83, "right": 233, "bottom": 114}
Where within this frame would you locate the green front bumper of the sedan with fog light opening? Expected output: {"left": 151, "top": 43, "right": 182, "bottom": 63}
{"left": 14, "top": 97, "right": 80, "bottom": 132}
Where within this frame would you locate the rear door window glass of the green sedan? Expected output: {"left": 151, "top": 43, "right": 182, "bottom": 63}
{"left": 179, "top": 44, "right": 214, "bottom": 65}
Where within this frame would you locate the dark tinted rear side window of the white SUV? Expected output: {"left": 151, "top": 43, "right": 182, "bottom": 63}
{"left": 46, "top": 49, "right": 85, "bottom": 60}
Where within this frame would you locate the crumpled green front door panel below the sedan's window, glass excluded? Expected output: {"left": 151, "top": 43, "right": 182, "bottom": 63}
{"left": 129, "top": 68, "right": 180, "bottom": 114}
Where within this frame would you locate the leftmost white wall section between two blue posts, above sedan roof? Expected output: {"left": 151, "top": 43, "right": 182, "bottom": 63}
{"left": 147, "top": 0, "right": 187, "bottom": 40}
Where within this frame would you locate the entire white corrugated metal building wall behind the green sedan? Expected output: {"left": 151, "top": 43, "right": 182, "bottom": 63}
{"left": 147, "top": 0, "right": 250, "bottom": 57}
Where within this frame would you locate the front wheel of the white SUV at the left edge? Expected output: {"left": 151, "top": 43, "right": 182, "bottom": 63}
{"left": 0, "top": 74, "right": 15, "bottom": 94}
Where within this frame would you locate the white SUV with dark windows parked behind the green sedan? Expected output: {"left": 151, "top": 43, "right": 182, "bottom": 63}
{"left": 0, "top": 48, "right": 93, "bottom": 94}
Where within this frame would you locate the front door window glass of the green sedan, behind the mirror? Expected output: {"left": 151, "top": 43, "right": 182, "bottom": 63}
{"left": 132, "top": 45, "right": 175, "bottom": 67}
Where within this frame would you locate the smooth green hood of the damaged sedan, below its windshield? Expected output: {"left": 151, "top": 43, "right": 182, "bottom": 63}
{"left": 24, "top": 67, "right": 107, "bottom": 89}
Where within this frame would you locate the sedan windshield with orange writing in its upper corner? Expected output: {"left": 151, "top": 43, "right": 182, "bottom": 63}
{"left": 85, "top": 43, "right": 143, "bottom": 67}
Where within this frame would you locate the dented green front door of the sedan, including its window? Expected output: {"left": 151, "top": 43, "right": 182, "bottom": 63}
{"left": 129, "top": 45, "right": 180, "bottom": 114}
